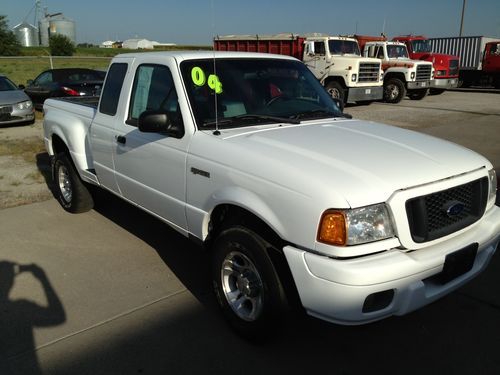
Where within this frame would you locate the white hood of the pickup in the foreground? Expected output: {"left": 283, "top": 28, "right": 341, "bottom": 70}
{"left": 214, "top": 119, "right": 491, "bottom": 208}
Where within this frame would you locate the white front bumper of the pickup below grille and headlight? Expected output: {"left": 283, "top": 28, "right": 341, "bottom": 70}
{"left": 284, "top": 207, "right": 500, "bottom": 325}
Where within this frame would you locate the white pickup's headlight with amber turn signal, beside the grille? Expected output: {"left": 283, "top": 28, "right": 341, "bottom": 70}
{"left": 317, "top": 203, "right": 394, "bottom": 246}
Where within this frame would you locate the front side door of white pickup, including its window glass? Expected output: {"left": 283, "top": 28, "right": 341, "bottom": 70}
{"left": 113, "top": 64, "right": 188, "bottom": 231}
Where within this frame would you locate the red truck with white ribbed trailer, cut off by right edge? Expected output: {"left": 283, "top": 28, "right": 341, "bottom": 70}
{"left": 429, "top": 36, "right": 500, "bottom": 88}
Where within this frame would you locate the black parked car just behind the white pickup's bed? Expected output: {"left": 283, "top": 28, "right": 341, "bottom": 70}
{"left": 24, "top": 68, "right": 106, "bottom": 109}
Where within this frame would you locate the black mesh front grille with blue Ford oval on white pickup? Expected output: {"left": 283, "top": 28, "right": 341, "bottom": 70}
{"left": 406, "top": 177, "right": 488, "bottom": 243}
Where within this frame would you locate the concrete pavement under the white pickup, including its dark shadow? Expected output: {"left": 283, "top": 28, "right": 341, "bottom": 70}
{"left": 0, "top": 194, "right": 500, "bottom": 375}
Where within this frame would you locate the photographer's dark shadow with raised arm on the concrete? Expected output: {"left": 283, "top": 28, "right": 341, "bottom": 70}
{"left": 0, "top": 261, "right": 66, "bottom": 375}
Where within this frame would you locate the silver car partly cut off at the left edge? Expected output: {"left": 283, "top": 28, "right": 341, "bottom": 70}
{"left": 0, "top": 75, "right": 35, "bottom": 125}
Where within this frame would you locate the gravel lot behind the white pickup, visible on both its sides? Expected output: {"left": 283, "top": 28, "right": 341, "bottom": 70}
{"left": 0, "top": 91, "right": 500, "bottom": 209}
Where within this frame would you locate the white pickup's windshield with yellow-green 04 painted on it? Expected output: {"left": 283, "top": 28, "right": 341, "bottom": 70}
{"left": 181, "top": 58, "right": 342, "bottom": 129}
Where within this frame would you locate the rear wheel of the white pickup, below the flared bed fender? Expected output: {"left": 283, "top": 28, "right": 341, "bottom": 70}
{"left": 52, "top": 153, "right": 94, "bottom": 213}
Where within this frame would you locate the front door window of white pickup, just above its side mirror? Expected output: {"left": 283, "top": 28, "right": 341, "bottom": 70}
{"left": 127, "top": 64, "right": 182, "bottom": 126}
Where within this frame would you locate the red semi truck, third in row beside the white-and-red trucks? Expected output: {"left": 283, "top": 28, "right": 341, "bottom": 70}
{"left": 392, "top": 35, "right": 459, "bottom": 94}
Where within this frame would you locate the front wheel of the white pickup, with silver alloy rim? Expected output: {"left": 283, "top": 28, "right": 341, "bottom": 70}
{"left": 211, "top": 226, "right": 286, "bottom": 340}
